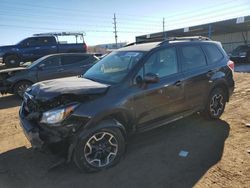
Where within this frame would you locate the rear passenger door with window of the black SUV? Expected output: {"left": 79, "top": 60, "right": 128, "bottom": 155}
{"left": 179, "top": 44, "right": 211, "bottom": 109}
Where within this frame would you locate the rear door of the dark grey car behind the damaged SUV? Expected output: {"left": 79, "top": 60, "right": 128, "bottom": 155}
{"left": 61, "top": 54, "right": 94, "bottom": 76}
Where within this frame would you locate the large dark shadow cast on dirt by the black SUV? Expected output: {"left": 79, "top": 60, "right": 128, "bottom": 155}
{"left": 0, "top": 115, "right": 230, "bottom": 188}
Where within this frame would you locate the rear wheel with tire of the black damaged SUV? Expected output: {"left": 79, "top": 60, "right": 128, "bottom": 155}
{"left": 203, "top": 88, "right": 226, "bottom": 119}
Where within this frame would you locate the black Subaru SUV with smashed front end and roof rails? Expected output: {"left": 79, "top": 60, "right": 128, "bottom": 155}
{"left": 20, "top": 37, "right": 234, "bottom": 172}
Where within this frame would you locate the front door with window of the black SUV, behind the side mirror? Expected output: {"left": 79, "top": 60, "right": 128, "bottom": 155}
{"left": 134, "top": 47, "right": 185, "bottom": 127}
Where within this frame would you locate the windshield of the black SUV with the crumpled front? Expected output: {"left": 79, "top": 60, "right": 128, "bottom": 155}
{"left": 83, "top": 51, "right": 143, "bottom": 83}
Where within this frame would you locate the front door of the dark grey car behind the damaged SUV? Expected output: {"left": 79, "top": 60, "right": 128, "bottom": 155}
{"left": 37, "top": 55, "right": 63, "bottom": 81}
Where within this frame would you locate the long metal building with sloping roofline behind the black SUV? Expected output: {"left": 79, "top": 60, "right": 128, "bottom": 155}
{"left": 135, "top": 16, "right": 250, "bottom": 52}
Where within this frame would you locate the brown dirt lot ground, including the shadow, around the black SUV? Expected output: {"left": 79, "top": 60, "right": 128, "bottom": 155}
{"left": 0, "top": 73, "right": 250, "bottom": 188}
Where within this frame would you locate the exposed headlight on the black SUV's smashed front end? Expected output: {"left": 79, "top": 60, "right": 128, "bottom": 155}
{"left": 40, "top": 104, "right": 77, "bottom": 126}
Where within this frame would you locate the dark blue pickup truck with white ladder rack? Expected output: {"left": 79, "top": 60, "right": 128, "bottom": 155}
{"left": 0, "top": 32, "right": 87, "bottom": 67}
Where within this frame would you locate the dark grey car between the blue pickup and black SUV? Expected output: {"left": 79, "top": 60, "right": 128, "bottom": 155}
{"left": 0, "top": 53, "right": 98, "bottom": 97}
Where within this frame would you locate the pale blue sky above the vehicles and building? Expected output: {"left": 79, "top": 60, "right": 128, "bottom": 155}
{"left": 0, "top": 0, "right": 250, "bottom": 46}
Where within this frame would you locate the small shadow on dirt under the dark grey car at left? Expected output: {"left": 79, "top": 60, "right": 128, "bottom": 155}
{"left": 0, "top": 94, "right": 22, "bottom": 110}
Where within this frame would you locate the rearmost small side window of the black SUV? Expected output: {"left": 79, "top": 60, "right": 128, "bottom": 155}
{"left": 202, "top": 45, "right": 224, "bottom": 64}
